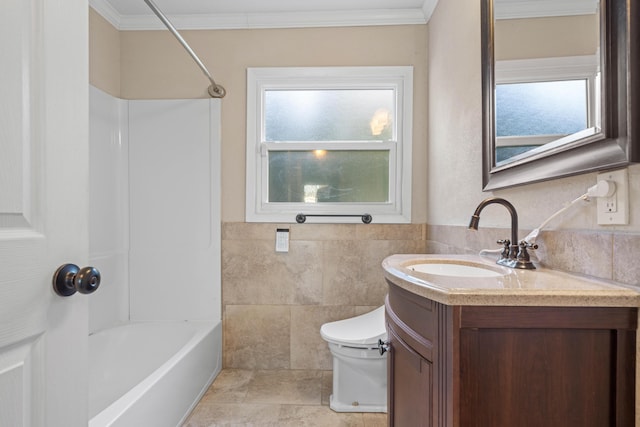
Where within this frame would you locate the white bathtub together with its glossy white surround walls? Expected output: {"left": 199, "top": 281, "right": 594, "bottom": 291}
{"left": 89, "top": 88, "right": 222, "bottom": 427}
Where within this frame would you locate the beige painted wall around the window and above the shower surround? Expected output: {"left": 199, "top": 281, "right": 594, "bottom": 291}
{"left": 115, "top": 21, "right": 427, "bottom": 223}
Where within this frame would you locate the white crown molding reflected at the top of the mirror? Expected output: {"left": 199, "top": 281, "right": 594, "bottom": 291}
{"left": 494, "top": 0, "right": 598, "bottom": 19}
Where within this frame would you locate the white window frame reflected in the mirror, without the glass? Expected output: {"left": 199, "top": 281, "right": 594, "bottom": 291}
{"left": 495, "top": 55, "right": 601, "bottom": 147}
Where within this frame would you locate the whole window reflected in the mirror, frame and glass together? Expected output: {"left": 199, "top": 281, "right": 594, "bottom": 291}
{"left": 495, "top": 56, "right": 600, "bottom": 165}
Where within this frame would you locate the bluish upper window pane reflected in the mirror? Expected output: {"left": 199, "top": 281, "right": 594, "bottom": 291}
{"left": 496, "top": 80, "right": 588, "bottom": 137}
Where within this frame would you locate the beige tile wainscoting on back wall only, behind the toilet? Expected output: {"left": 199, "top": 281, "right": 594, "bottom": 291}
{"left": 222, "top": 223, "right": 425, "bottom": 370}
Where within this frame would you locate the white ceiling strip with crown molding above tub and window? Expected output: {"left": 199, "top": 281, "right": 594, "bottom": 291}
{"left": 89, "top": 0, "right": 438, "bottom": 30}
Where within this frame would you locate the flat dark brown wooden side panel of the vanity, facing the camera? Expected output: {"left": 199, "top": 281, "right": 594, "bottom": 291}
{"left": 457, "top": 307, "right": 637, "bottom": 427}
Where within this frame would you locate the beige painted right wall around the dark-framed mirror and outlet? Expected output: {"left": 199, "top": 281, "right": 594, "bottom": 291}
{"left": 427, "top": 0, "right": 640, "bottom": 234}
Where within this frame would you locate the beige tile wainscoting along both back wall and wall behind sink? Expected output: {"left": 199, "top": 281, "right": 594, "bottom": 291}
{"left": 222, "top": 223, "right": 640, "bottom": 370}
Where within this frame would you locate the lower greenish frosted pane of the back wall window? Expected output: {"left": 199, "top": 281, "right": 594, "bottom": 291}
{"left": 269, "top": 150, "right": 389, "bottom": 203}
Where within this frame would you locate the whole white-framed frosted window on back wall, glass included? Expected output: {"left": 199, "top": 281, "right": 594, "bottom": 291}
{"left": 246, "top": 67, "right": 413, "bottom": 223}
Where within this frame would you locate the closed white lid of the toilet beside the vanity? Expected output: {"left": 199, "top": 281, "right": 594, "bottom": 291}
{"left": 320, "top": 306, "right": 387, "bottom": 345}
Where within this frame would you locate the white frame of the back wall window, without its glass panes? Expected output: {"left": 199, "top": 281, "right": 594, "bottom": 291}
{"left": 245, "top": 66, "right": 413, "bottom": 223}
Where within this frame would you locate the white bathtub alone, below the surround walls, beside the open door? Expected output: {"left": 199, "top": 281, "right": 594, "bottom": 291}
{"left": 89, "top": 321, "right": 222, "bottom": 427}
